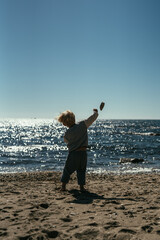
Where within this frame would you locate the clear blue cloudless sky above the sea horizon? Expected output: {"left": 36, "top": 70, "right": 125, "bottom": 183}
{"left": 0, "top": 0, "right": 160, "bottom": 119}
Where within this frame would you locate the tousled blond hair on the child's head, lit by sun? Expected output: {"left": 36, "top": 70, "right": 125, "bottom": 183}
{"left": 57, "top": 110, "right": 75, "bottom": 127}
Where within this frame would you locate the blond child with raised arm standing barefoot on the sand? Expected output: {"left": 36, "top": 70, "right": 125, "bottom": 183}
{"left": 58, "top": 109, "right": 98, "bottom": 192}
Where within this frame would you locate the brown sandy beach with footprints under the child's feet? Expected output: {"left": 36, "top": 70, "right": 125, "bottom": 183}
{"left": 0, "top": 172, "right": 160, "bottom": 240}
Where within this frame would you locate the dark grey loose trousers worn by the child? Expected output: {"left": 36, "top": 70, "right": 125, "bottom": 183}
{"left": 61, "top": 151, "right": 87, "bottom": 185}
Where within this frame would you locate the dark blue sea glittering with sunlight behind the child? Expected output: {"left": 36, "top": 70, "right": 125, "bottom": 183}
{"left": 0, "top": 119, "right": 160, "bottom": 174}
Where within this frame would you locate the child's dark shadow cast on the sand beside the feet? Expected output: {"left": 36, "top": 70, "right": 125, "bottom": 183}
{"left": 69, "top": 189, "right": 105, "bottom": 204}
